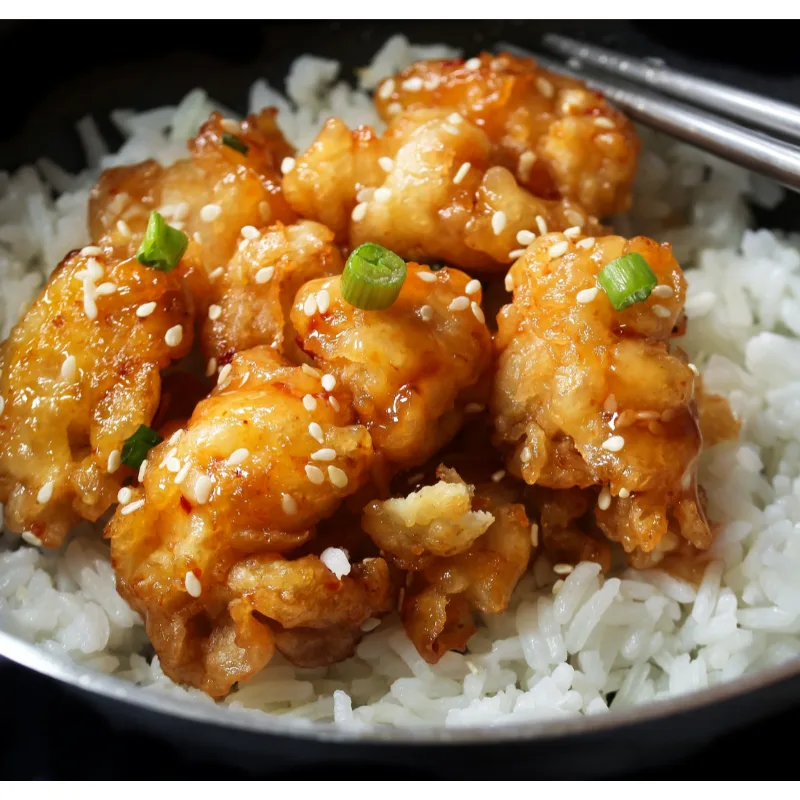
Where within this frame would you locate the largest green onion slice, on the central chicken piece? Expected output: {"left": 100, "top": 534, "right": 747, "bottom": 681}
{"left": 342, "top": 242, "right": 406, "bottom": 311}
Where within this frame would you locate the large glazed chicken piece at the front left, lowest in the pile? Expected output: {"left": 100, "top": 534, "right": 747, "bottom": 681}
{"left": 107, "top": 347, "right": 393, "bottom": 697}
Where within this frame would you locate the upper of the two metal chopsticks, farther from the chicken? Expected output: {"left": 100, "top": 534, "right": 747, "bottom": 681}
{"left": 542, "top": 34, "right": 800, "bottom": 140}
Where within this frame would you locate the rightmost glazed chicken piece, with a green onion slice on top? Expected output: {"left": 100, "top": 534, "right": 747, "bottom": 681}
{"left": 492, "top": 235, "right": 712, "bottom": 553}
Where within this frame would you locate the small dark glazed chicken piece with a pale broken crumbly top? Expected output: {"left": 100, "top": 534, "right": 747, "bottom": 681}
{"left": 362, "top": 467, "right": 532, "bottom": 664}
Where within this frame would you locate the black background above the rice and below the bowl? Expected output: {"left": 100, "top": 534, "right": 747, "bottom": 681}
{"left": 0, "top": 21, "right": 800, "bottom": 780}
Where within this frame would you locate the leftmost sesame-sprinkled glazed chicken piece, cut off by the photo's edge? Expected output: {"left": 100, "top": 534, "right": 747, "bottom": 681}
{"left": 0, "top": 243, "right": 193, "bottom": 547}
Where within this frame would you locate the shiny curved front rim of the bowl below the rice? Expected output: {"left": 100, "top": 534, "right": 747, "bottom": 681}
{"left": 0, "top": 630, "right": 800, "bottom": 746}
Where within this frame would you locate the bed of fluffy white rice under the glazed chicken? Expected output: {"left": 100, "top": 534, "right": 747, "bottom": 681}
{"left": 0, "top": 37, "right": 800, "bottom": 726}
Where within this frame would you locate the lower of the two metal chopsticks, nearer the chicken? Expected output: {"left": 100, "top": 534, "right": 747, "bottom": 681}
{"left": 496, "top": 43, "right": 800, "bottom": 192}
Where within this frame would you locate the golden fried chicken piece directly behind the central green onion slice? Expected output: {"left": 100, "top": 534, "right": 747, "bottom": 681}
{"left": 283, "top": 109, "right": 599, "bottom": 271}
